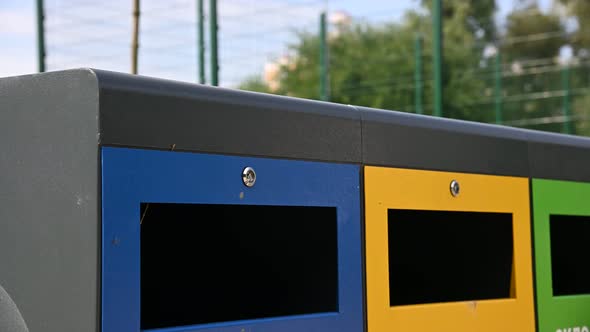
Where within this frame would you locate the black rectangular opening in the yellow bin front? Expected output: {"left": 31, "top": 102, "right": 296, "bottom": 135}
{"left": 388, "top": 209, "right": 513, "bottom": 306}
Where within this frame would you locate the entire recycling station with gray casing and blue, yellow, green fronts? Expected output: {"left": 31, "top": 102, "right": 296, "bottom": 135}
{"left": 0, "top": 68, "right": 590, "bottom": 332}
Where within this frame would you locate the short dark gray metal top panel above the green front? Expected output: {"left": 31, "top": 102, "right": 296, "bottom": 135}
{"left": 527, "top": 131, "right": 590, "bottom": 182}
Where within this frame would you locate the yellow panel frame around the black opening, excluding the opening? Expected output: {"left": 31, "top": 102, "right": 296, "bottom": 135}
{"left": 365, "top": 166, "right": 535, "bottom": 332}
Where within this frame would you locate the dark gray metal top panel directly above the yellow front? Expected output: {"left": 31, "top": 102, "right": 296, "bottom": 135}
{"left": 358, "top": 107, "right": 529, "bottom": 176}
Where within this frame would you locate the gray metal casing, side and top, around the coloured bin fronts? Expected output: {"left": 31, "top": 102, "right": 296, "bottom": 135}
{"left": 5, "top": 69, "right": 590, "bottom": 332}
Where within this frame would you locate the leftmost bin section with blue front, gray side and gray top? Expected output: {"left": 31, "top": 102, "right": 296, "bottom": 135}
{"left": 0, "top": 69, "right": 364, "bottom": 332}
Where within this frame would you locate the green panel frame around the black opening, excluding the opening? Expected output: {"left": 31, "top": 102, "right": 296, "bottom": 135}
{"left": 532, "top": 179, "right": 590, "bottom": 332}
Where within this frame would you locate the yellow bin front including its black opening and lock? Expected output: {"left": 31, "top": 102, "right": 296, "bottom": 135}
{"left": 364, "top": 166, "right": 535, "bottom": 332}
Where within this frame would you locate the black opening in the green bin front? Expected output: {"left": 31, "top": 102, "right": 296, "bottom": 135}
{"left": 549, "top": 215, "right": 590, "bottom": 296}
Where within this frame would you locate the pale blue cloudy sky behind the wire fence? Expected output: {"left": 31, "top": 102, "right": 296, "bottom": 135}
{"left": 0, "top": 0, "right": 551, "bottom": 87}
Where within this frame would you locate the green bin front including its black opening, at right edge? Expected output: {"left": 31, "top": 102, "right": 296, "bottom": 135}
{"left": 532, "top": 179, "right": 590, "bottom": 332}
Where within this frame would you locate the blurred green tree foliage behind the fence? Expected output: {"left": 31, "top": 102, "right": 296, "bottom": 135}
{"left": 241, "top": 0, "right": 590, "bottom": 135}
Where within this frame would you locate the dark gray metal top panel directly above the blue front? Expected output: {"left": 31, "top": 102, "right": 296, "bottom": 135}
{"left": 96, "top": 70, "right": 361, "bottom": 163}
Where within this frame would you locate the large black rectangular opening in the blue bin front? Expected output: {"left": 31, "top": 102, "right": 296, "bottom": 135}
{"left": 140, "top": 203, "right": 338, "bottom": 330}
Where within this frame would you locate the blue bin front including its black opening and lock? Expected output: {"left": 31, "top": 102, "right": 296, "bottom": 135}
{"left": 102, "top": 147, "right": 363, "bottom": 332}
